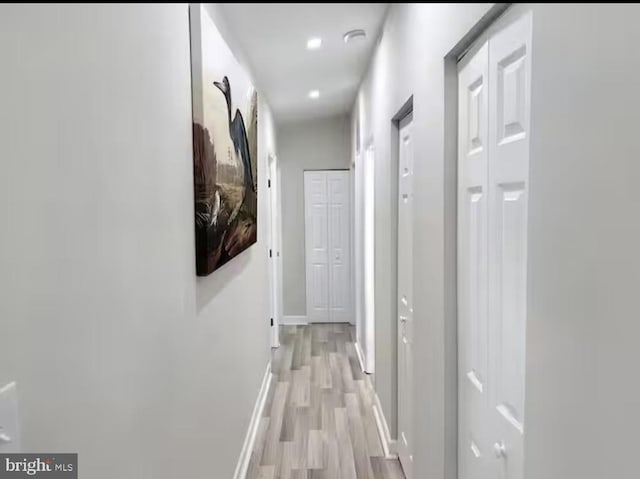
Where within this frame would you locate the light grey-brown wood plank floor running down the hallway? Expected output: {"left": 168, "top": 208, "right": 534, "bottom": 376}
{"left": 247, "top": 324, "right": 404, "bottom": 479}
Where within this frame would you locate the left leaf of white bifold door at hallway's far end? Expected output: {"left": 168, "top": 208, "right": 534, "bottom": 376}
{"left": 304, "top": 171, "right": 329, "bottom": 322}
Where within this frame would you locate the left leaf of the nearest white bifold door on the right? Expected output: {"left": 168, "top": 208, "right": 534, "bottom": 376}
{"left": 458, "top": 38, "right": 492, "bottom": 479}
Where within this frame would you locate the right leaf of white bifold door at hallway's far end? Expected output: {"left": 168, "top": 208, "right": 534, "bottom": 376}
{"left": 327, "top": 170, "right": 352, "bottom": 323}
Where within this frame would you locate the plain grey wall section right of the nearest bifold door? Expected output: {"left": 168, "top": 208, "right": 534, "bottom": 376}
{"left": 525, "top": 5, "right": 640, "bottom": 479}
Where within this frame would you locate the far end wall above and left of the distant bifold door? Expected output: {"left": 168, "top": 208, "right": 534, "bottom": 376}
{"left": 278, "top": 116, "right": 351, "bottom": 316}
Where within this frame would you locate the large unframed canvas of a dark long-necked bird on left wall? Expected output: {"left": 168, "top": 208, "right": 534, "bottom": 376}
{"left": 189, "top": 4, "right": 258, "bottom": 276}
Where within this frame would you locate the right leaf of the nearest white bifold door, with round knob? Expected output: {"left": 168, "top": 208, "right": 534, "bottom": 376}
{"left": 489, "top": 14, "right": 531, "bottom": 479}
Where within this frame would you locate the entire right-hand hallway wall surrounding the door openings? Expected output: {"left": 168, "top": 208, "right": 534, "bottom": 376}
{"left": 352, "top": 4, "right": 640, "bottom": 479}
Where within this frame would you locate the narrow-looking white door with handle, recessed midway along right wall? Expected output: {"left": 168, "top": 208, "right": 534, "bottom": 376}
{"left": 397, "top": 113, "right": 413, "bottom": 479}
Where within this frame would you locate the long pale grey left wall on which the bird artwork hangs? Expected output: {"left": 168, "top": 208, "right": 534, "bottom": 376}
{"left": 0, "top": 5, "right": 275, "bottom": 479}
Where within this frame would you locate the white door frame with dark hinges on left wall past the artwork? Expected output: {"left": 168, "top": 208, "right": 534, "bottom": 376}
{"left": 267, "top": 153, "right": 283, "bottom": 348}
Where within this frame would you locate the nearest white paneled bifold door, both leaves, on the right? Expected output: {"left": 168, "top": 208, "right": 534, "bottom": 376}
{"left": 458, "top": 11, "right": 531, "bottom": 479}
